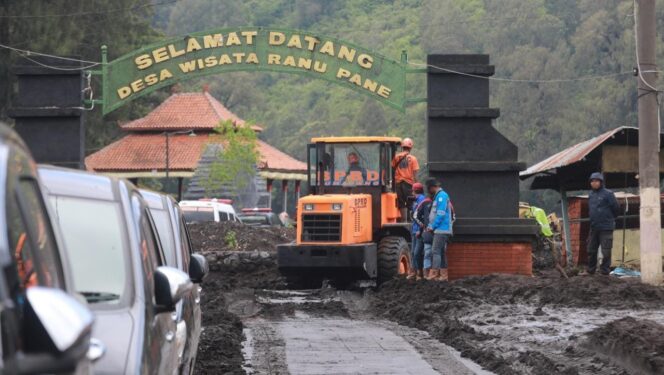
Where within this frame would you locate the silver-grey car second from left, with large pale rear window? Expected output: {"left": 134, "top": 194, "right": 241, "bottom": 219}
{"left": 39, "top": 166, "right": 192, "bottom": 374}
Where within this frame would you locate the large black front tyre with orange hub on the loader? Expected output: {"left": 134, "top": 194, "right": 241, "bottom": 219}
{"left": 378, "top": 236, "right": 410, "bottom": 284}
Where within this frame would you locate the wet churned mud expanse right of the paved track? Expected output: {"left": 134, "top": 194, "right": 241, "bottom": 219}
{"left": 372, "top": 275, "right": 664, "bottom": 374}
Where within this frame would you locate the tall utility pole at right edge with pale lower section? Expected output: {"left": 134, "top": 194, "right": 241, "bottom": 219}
{"left": 634, "top": 0, "right": 662, "bottom": 285}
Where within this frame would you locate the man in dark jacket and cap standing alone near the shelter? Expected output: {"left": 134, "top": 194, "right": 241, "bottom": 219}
{"left": 581, "top": 172, "right": 620, "bottom": 276}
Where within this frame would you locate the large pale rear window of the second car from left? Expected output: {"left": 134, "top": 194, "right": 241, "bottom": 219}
{"left": 51, "top": 196, "right": 127, "bottom": 304}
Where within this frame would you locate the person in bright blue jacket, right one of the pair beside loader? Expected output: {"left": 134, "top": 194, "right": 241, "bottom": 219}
{"left": 426, "top": 178, "right": 453, "bottom": 281}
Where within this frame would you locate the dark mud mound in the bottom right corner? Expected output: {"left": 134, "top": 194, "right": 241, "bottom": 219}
{"left": 588, "top": 317, "right": 664, "bottom": 374}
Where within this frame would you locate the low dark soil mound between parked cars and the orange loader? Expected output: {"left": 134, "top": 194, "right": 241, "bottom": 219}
{"left": 188, "top": 221, "right": 295, "bottom": 253}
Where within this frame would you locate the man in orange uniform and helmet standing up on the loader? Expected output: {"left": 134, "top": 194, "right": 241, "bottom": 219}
{"left": 392, "top": 138, "right": 420, "bottom": 221}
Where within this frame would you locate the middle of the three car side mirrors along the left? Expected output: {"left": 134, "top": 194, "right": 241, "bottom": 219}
{"left": 154, "top": 266, "right": 194, "bottom": 312}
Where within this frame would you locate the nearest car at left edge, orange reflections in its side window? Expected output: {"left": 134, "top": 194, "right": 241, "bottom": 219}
{"left": 0, "top": 125, "right": 96, "bottom": 374}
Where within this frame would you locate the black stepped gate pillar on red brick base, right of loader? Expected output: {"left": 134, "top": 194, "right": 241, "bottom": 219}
{"left": 427, "top": 55, "right": 538, "bottom": 278}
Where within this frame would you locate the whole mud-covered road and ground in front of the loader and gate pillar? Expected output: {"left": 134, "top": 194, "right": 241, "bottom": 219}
{"left": 189, "top": 223, "right": 664, "bottom": 374}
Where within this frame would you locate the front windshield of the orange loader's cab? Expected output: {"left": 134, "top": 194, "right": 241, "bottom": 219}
{"left": 309, "top": 143, "right": 381, "bottom": 186}
